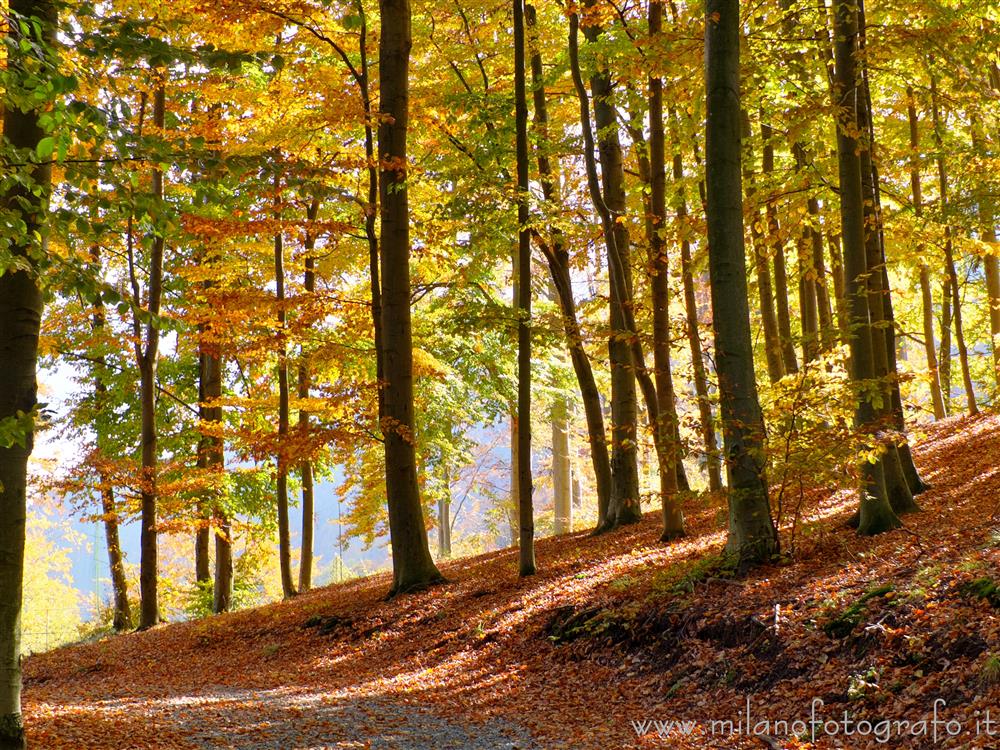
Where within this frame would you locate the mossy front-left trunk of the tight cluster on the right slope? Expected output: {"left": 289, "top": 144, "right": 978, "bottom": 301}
{"left": 833, "top": 0, "right": 901, "bottom": 535}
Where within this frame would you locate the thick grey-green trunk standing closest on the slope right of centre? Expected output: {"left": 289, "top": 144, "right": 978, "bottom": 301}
{"left": 705, "top": 0, "right": 778, "bottom": 568}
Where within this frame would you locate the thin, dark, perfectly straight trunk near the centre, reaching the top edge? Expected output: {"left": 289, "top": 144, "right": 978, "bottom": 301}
{"left": 514, "top": 0, "right": 535, "bottom": 577}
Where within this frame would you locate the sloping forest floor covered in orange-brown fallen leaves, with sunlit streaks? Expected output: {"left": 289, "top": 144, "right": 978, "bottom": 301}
{"left": 24, "top": 415, "right": 1000, "bottom": 750}
